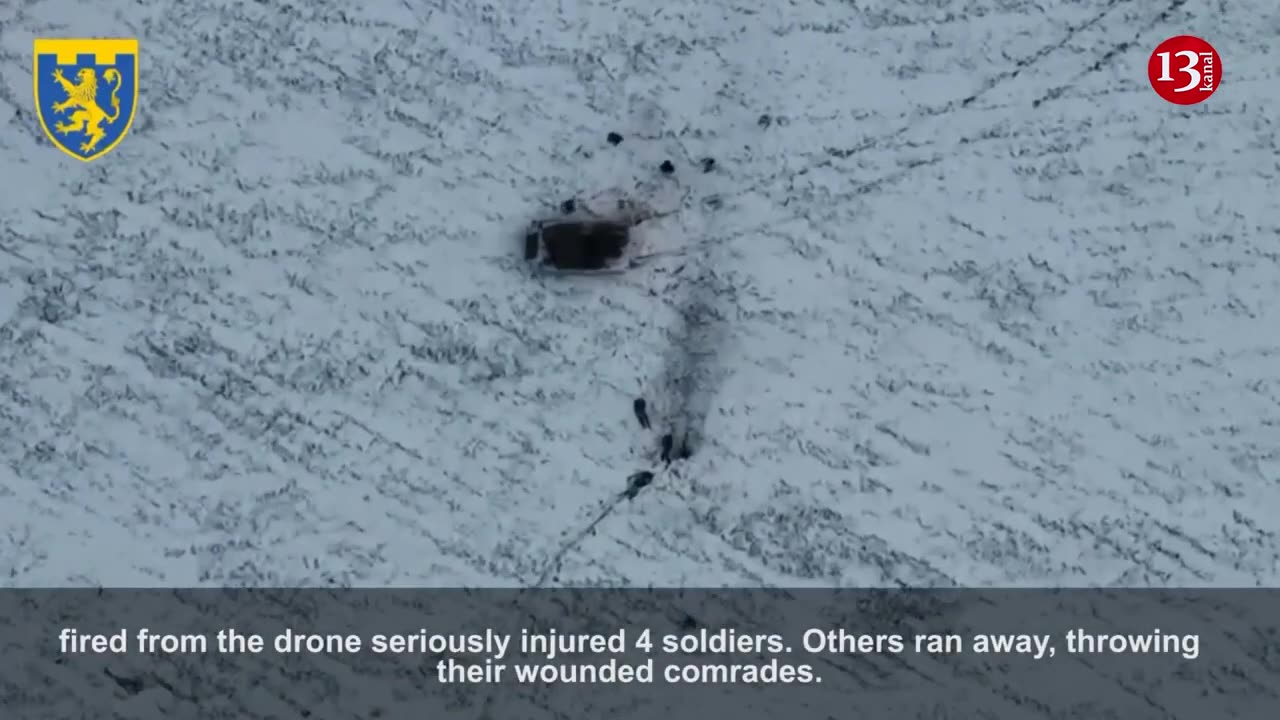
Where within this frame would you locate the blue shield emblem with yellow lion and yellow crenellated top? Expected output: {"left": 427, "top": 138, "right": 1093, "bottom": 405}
{"left": 35, "top": 38, "right": 138, "bottom": 163}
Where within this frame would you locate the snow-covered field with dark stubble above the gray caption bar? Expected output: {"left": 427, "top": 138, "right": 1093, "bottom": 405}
{"left": 0, "top": 0, "right": 1280, "bottom": 587}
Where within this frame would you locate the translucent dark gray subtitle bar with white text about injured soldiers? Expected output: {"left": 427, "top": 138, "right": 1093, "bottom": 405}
{"left": 0, "top": 589, "right": 1280, "bottom": 720}
